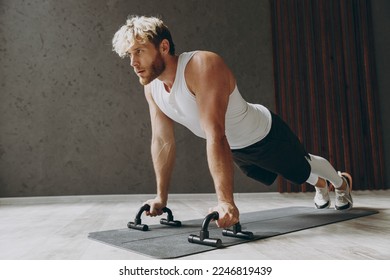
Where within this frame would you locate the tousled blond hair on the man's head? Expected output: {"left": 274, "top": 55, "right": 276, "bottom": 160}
{"left": 112, "top": 16, "right": 175, "bottom": 58}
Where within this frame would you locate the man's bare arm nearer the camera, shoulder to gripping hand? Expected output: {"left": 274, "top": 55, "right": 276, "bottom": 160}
{"left": 185, "top": 52, "right": 239, "bottom": 227}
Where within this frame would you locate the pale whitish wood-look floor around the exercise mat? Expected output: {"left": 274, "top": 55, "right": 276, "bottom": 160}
{"left": 0, "top": 190, "right": 390, "bottom": 260}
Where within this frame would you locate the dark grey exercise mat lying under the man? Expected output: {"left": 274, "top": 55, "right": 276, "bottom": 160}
{"left": 88, "top": 207, "right": 378, "bottom": 259}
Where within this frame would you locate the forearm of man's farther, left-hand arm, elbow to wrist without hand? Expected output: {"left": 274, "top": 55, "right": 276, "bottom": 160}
{"left": 151, "top": 140, "right": 176, "bottom": 202}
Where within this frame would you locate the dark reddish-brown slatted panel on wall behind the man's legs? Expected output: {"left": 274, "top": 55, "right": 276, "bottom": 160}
{"left": 270, "top": 0, "right": 385, "bottom": 192}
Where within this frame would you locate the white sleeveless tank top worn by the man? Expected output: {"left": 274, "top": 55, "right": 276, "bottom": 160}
{"left": 151, "top": 52, "right": 271, "bottom": 149}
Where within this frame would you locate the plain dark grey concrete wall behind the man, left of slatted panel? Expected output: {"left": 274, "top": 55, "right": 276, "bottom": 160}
{"left": 0, "top": 0, "right": 275, "bottom": 197}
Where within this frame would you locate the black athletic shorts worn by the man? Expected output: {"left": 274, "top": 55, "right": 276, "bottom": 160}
{"left": 232, "top": 113, "right": 311, "bottom": 185}
